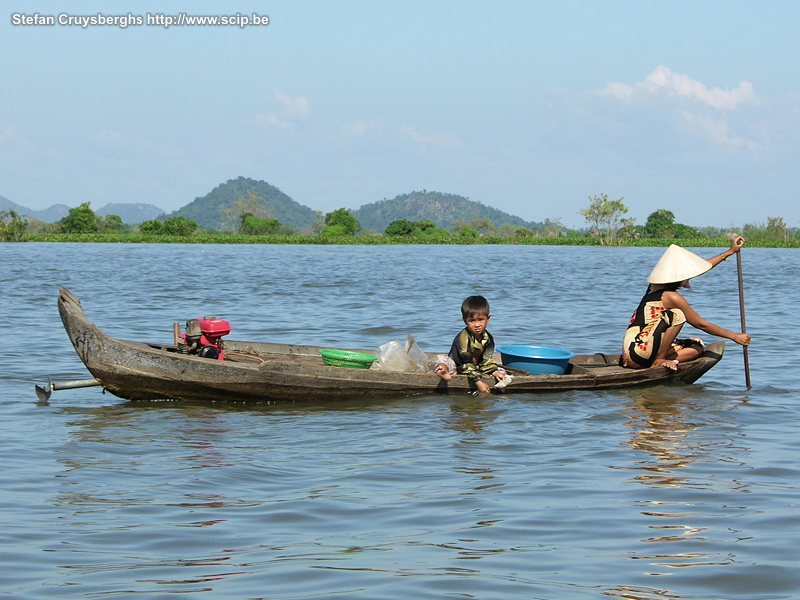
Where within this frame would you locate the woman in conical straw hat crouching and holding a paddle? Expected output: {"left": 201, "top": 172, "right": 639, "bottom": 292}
{"left": 620, "top": 236, "right": 750, "bottom": 369}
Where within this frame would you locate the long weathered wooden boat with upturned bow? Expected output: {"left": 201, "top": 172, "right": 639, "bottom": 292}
{"left": 48, "top": 288, "right": 725, "bottom": 401}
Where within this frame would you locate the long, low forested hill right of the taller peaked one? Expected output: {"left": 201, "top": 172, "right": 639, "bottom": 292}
{"left": 352, "top": 190, "right": 532, "bottom": 233}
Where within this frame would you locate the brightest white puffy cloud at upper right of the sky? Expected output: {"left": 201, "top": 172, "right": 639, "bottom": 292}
{"left": 599, "top": 66, "right": 759, "bottom": 110}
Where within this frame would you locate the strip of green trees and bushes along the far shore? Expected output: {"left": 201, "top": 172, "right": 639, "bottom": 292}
{"left": 0, "top": 192, "right": 797, "bottom": 245}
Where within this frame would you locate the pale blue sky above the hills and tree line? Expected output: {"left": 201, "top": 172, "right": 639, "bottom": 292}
{"left": 0, "top": 0, "right": 800, "bottom": 228}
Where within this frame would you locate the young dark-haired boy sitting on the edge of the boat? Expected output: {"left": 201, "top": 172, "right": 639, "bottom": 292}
{"left": 433, "top": 296, "right": 506, "bottom": 393}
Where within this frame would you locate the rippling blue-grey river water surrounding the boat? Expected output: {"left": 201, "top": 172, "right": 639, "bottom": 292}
{"left": 0, "top": 244, "right": 800, "bottom": 600}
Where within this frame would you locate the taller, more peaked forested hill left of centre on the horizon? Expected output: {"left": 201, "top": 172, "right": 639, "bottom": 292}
{"left": 168, "top": 177, "right": 317, "bottom": 230}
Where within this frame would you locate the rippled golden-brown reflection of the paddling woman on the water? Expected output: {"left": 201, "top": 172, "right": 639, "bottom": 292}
{"left": 607, "top": 387, "right": 747, "bottom": 580}
